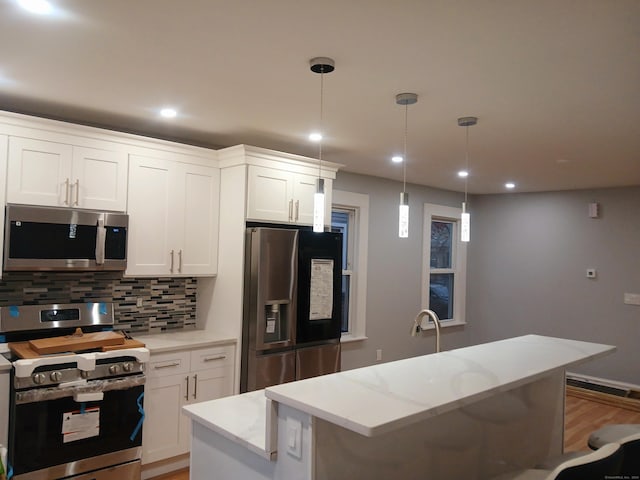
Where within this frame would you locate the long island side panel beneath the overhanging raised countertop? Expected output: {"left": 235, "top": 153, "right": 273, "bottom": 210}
{"left": 314, "top": 370, "right": 565, "bottom": 480}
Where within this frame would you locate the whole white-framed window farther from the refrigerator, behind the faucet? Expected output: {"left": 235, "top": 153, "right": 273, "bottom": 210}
{"left": 422, "top": 203, "right": 467, "bottom": 325}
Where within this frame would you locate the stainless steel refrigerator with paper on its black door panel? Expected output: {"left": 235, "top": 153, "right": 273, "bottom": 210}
{"left": 240, "top": 227, "right": 342, "bottom": 392}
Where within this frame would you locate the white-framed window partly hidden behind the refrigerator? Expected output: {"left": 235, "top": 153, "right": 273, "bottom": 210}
{"left": 331, "top": 190, "right": 369, "bottom": 342}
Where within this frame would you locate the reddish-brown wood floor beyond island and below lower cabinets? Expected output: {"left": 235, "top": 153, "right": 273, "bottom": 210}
{"left": 154, "top": 387, "right": 640, "bottom": 480}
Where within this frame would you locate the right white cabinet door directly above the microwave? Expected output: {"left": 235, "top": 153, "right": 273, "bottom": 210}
{"left": 71, "top": 147, "right": 127, "bottom": 212}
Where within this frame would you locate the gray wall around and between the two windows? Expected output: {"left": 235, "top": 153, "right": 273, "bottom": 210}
{"left": 334, "top": 172, "right": 470, "bottom": 370}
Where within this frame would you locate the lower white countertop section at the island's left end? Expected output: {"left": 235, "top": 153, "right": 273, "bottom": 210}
{"left": 182, "top": 390, "right": 277, "bottom": 460}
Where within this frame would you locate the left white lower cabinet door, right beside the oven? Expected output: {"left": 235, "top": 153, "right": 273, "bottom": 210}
{"left": 142, "top": 375, "right": 190, "bottom": 463}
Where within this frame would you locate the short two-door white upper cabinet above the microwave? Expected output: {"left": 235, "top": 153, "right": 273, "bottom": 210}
{"left": 7, "top": 136, "right": 127, "bottom": 211}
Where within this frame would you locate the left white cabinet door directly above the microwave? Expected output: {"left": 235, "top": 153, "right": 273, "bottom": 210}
{"left": 7, "top": 137, "right": 73, "bottom": 207}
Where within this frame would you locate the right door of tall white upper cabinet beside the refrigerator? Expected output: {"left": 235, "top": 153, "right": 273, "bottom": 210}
{"left": 175, "top": 164, "right": 220, "bottom": 275}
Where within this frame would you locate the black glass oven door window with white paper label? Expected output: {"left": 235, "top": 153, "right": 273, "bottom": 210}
{"left": 9, "top": 385, "right": 144, "bottom": 475}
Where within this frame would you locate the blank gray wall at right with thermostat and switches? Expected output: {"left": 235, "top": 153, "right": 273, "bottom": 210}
{"left": 467, "top": 187, "right": 640, "bottom": 385}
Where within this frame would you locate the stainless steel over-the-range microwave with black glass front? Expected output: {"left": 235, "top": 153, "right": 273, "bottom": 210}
{"left": 4, "top": 205, "right": 129, "bottom": 271}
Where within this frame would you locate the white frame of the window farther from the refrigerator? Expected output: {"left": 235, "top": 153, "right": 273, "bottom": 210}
{"left": 421, "top": 203, "right": 467, "bottom": 328}
